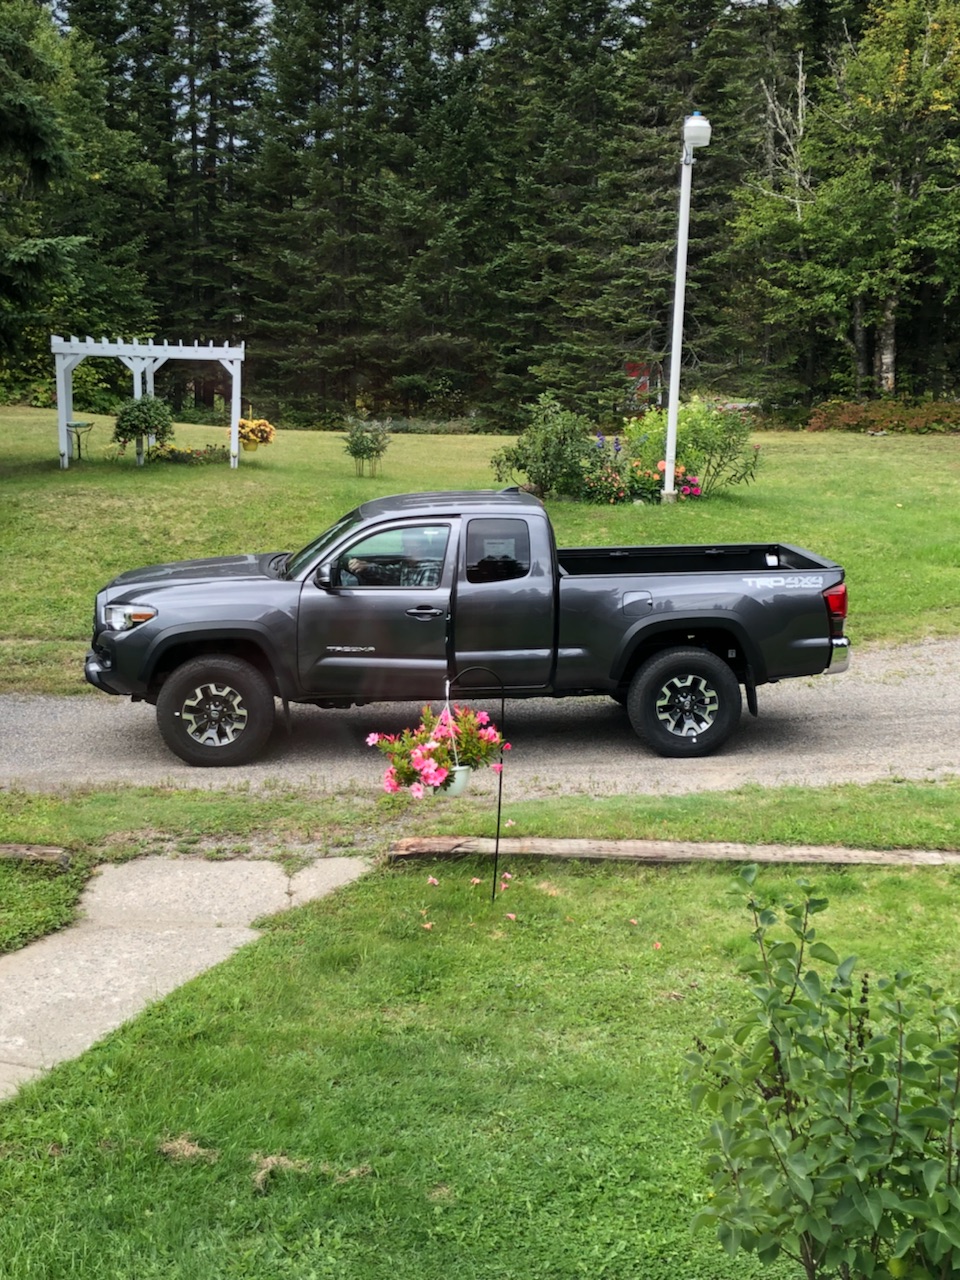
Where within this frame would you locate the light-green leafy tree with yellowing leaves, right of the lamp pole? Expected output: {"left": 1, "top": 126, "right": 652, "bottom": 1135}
{"left": 739, "top": 0, "right": 960, "bottom": 394}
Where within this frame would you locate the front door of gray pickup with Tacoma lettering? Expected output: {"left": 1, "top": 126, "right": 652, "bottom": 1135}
{"left": 297, "top": 521, "right": 456, "bottom": 700}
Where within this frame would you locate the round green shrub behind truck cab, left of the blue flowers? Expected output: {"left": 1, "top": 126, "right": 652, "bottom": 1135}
{"left": 490, "top": 394, "right": 595, "bottom": 498}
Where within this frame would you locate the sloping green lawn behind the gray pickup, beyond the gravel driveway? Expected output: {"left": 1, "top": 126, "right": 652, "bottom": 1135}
{"left": 0, "top": 408, "right": 960, "bottom": 692}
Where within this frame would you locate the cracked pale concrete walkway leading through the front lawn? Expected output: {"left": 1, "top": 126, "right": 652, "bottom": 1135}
{"left": 0, "top": 858, "right": 367, "bottom": 1098}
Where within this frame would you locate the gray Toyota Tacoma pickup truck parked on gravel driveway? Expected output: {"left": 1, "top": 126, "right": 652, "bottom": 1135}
{"left": 84, "top": 490, "right": 849, "bottom": 765}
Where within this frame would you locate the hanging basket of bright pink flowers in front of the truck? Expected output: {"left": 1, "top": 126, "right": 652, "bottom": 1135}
{"left": 366, "top": 704, "right": 509, "bottom": 800}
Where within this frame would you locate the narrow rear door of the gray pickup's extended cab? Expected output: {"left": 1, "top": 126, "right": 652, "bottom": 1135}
{"left": 453, "top": 516, "right": 554, "bottom": 690}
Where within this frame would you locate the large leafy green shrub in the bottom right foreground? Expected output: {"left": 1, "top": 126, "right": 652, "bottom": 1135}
{"left": 687, "top": 867, "right": 960, "bottom": 1280}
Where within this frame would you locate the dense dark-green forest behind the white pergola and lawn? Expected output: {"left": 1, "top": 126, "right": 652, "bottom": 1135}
{"left": 0, "top": 0, "right": 960, "bottom": 428}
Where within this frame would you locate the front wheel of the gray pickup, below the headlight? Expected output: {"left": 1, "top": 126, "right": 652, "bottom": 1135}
{"left": 156, "top": 654, "right": 275, "bottom": 767}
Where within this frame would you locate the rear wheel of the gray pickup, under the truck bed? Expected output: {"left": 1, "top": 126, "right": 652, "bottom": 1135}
{"left": 627, "top": 648, "right": 742, "bottom": 756}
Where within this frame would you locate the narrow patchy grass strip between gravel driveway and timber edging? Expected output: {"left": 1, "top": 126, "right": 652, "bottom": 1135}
{"left": 0, "top": 778, "right": 960, "bottom": 954}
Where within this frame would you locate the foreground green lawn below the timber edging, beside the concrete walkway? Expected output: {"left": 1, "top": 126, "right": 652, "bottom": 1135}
{"left": 7, "top": 861, "right": 960, "bottom": 1280}
